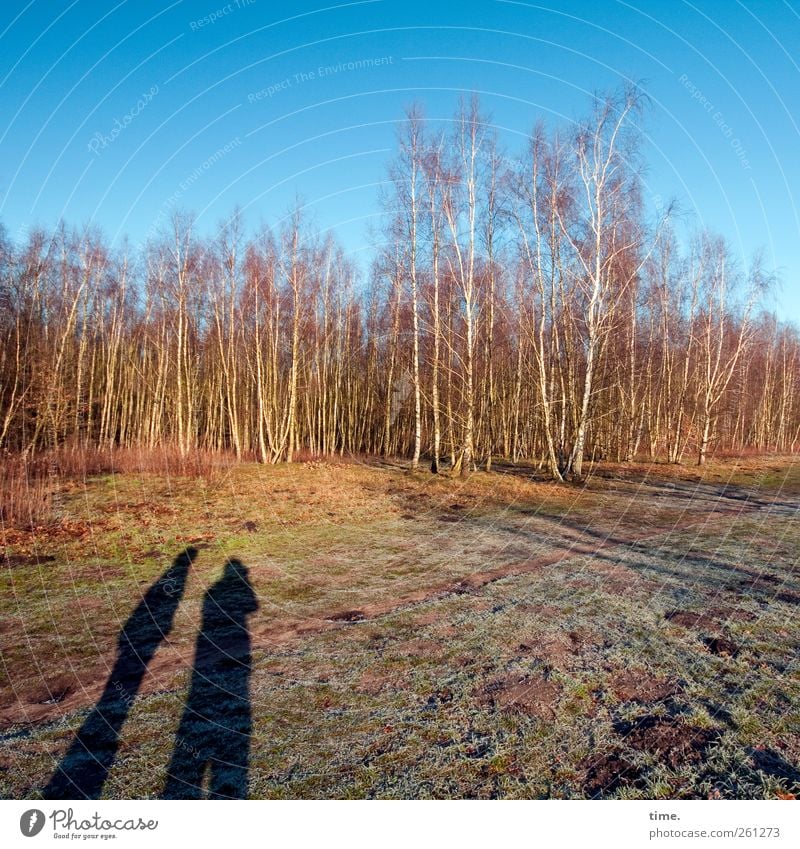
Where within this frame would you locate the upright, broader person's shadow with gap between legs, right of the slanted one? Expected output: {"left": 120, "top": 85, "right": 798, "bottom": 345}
{"left": 163, "top": 560, "right": 258, "bottom": 799}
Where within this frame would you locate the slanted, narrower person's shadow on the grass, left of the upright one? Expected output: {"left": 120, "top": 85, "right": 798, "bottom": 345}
{"left": 42, "top": 548, "right": 197, "bottom": 799}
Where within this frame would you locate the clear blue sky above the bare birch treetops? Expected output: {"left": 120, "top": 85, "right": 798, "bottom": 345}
{"left": 0, "top": 0, "right": 800, "bottom": 321}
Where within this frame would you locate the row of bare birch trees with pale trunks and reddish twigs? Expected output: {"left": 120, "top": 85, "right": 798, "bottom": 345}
{"left": 0, "top": 89, "right": 800, "bottom": 480}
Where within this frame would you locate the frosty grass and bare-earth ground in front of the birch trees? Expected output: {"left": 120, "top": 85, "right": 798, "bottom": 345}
{"left": 0, "top": 457, "right": 800, "bottom": 798}
